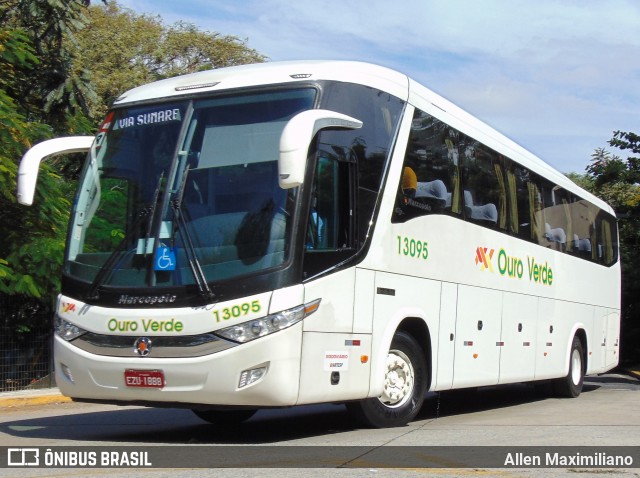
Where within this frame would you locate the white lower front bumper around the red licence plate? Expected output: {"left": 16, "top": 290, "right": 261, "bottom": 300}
{"left": 54, "top": 323, "right": 302, "bottom": 407}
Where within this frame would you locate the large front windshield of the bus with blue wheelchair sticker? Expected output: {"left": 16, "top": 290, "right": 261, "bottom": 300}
{"left": 65, "top": 88, "right": 316, "bottom": 288}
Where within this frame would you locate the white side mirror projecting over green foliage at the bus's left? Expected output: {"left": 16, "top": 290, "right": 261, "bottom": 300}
{"left": 17, "top": 136, "right": 93, "bottom": 206}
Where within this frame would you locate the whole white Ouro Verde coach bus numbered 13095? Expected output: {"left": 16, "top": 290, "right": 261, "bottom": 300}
{"left": 18, "top": 61, "right": 620, "bottom": 427}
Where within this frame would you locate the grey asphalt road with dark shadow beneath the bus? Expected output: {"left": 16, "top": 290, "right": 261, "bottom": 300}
{"left": 0, "top": 375, "right": 640, "bottom": 478}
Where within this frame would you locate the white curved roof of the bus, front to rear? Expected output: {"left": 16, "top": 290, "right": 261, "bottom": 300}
{"left": 114, "top": 60, "right": 614, "bottom": 214}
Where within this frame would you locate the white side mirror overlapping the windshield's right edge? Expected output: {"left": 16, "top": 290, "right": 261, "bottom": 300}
{"left": 278, "top": 110, "right": 362, "bottom": 189}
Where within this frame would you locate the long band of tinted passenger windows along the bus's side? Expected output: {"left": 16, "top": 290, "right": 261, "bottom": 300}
{"left": 391, "top": 109, "right": 618, "bottom": 265}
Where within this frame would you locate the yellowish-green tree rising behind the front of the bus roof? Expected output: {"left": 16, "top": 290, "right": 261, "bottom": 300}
{"left": 73, "top": 1, "right": 265, "bottom": 118}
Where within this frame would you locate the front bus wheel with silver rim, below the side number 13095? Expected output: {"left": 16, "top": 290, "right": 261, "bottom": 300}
{"left": 347, "top": 332, "right": 427, "bottom": 428}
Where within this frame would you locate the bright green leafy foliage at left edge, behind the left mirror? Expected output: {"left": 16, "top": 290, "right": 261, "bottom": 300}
{"left": 0, "top": 30, "right": 69, "bottom": 297}
